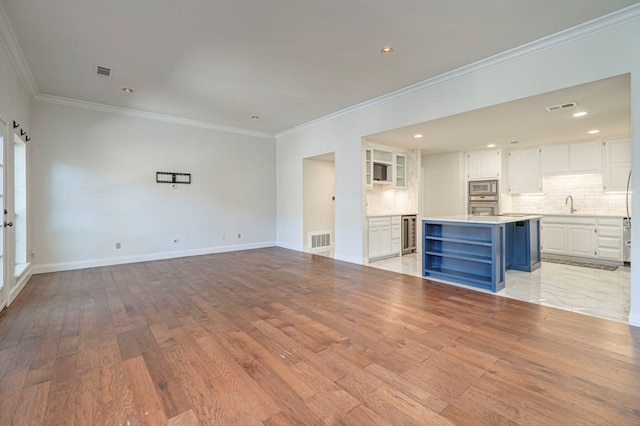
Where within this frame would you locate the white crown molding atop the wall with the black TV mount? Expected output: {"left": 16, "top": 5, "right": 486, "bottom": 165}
{"left": 33, "top": 94, "right": 275, "bottom": 140}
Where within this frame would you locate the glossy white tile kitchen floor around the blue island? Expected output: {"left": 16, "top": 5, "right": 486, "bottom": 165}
{"left": 369, "top": 253, "right": 631, "bottom": 323}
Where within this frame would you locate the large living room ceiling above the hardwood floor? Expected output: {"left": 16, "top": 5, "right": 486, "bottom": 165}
{"left": 2, "top": 0, "right": 639, "bottom": 134}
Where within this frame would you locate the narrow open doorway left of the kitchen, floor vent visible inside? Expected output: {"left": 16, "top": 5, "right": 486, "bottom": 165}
{"left": 302, "top": 152, "right": 335, "bottom": 257}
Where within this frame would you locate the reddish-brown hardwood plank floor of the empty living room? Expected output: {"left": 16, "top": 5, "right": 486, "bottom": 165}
{"left": 0, "top": 248, "right": 640, "bottom": 425}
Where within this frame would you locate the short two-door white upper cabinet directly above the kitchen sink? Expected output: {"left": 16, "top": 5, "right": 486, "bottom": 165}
{"left": 542, "top": 140, "right": 601, "bottom": 175}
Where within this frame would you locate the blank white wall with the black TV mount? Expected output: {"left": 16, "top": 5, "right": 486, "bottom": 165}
{"left": 31, "top": 102, "right": 275, "bottom": 272}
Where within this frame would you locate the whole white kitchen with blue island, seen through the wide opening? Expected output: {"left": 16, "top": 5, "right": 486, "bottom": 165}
{"left": 363, "top": 76, "right": 631, "bottom": 322}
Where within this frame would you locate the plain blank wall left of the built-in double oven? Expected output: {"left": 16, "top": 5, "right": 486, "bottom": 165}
{"left": 422, "top": 152, "right": 467, "bottom": 216}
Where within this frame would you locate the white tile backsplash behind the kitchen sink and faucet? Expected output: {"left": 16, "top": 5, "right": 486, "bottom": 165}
{"left": 511, "top": 173, "right": 631, "bottom": 216}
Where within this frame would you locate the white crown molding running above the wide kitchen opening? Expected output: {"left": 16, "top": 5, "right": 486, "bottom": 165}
{"left": 275, "top": 4, "right": 640, "bottom": 138}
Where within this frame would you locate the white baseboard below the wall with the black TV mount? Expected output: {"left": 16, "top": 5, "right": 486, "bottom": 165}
{"left": 32, "top": 241, "right": 276, "bottom": 275}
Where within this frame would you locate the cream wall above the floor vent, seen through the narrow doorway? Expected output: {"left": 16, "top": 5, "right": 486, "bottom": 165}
{"left": 304, "top": 158, "right": 336, "bottom": 250}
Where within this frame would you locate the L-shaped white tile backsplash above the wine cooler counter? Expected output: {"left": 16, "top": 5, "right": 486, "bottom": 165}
{"left": 367, "top": 150, "right": 420, "bottom": 216}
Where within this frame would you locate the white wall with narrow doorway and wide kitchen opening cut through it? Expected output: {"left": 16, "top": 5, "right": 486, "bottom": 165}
{"left": 277, "top": 11, "right": 640, "bottom": 325}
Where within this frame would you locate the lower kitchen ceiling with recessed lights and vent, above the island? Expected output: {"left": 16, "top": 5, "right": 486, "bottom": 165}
{"left": 367, "top": 74, "right": 631, "bottom": 154}
